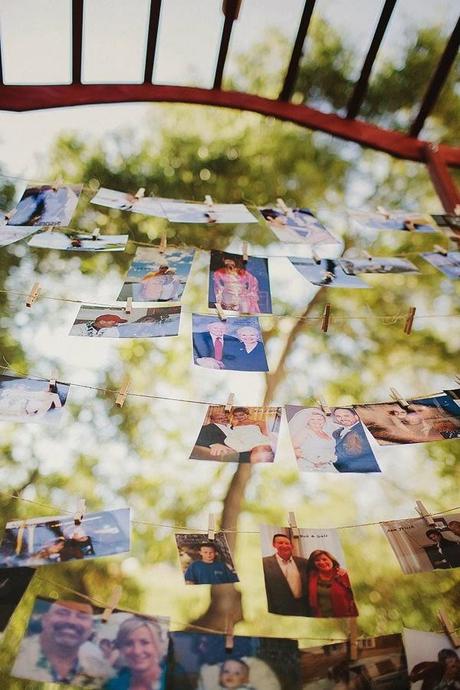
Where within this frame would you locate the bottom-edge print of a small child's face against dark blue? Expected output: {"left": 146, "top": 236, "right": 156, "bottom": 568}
{"left": 170, "top": 632, "right": 301, "bottom": 690}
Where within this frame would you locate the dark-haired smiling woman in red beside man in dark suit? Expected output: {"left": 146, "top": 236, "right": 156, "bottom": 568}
{"left": 307, "top": 549, "right": 358, "bottom": 618}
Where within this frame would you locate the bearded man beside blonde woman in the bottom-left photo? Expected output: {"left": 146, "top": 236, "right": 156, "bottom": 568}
{"left": 11, "top": 601, "right": 114, "bottom": 688}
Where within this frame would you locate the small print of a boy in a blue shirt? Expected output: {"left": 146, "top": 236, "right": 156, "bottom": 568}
{"left": 176, "top": 532, "right": 239, "bottom": 585}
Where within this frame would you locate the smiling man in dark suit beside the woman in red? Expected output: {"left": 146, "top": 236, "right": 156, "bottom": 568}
{"left": 262, "top": 534, "right": 309, "bottom": 616}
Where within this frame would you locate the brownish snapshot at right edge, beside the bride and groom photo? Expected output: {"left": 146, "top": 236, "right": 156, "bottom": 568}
{"left": 354, "top": 394, "right": 460, "bottom": 446}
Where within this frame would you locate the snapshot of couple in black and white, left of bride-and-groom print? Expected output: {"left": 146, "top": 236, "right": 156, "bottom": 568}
{"left": 190, "top": 405, "right": 281, "bottom": 464}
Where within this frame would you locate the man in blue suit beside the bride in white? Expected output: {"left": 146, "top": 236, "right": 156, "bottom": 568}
{"left": 332, "top": 407, "right": 380, "bottom": 472}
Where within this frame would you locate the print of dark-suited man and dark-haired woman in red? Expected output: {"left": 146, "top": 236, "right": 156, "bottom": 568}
{"left": 260, "top": 525, "right": 358, "bottom": 618}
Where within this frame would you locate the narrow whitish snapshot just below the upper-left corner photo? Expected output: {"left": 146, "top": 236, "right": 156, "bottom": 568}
{"left": 28, "top": 230, "right": 128, "bottom": 252}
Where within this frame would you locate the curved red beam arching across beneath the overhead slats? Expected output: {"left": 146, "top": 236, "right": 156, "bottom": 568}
{"left": 0, "top": 84, "right": 460, "bottom": 167}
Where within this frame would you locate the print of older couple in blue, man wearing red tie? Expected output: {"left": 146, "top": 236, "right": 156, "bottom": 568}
{"left": 192, "top": 314, "right": 268, "bottom": 371}
